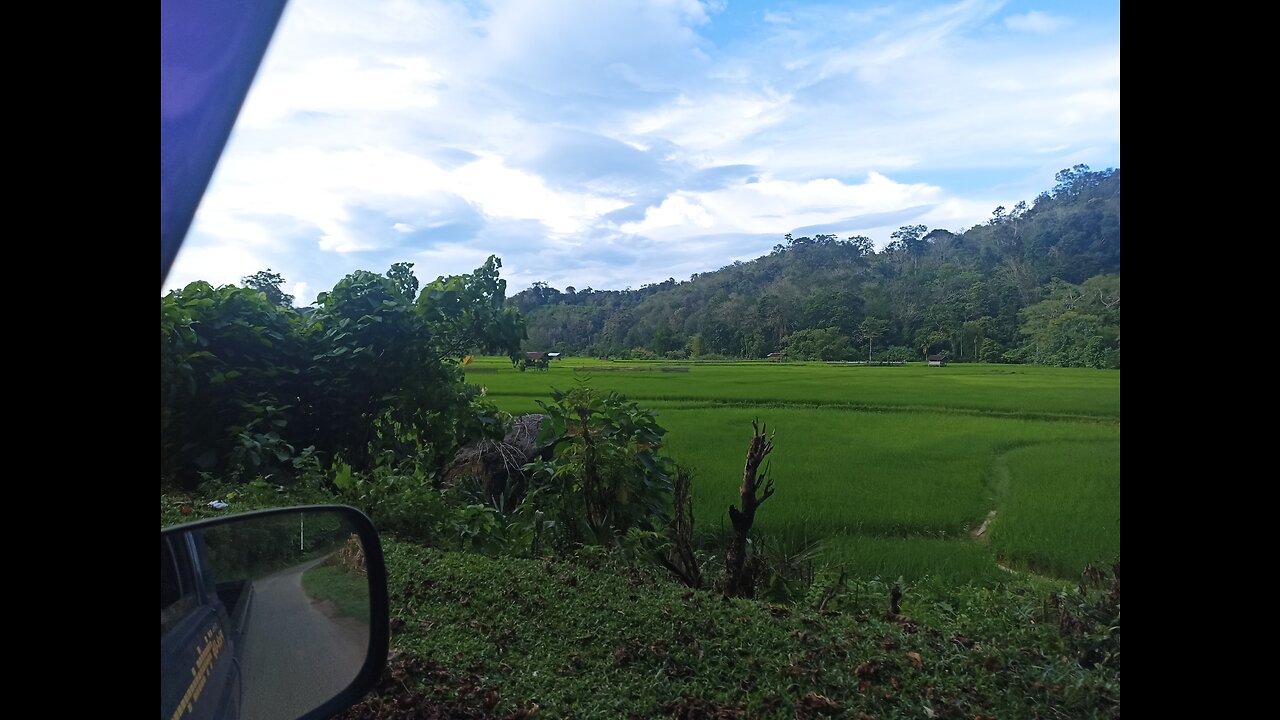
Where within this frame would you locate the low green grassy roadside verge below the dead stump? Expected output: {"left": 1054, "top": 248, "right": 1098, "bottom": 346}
{"left": 366, "top": 541, "right": 1120, "bottom": 719}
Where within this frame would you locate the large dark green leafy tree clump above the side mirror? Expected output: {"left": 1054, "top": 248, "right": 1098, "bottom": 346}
{"left": 160, "top": 258, "right": 524, "bottom": 489}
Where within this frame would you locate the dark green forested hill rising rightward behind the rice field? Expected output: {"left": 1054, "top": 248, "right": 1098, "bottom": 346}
{"left": 508, "top": 165, "right": 1120, "bottom": 368}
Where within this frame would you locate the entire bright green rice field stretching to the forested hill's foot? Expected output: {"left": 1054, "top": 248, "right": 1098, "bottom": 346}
{"left": 467, "top": 357, "right": 1120, "bottom": 579}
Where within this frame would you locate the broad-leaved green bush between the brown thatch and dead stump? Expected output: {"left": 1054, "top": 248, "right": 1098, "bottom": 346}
{"left": 525, "top": 384, "right": 675, "bottom": 547}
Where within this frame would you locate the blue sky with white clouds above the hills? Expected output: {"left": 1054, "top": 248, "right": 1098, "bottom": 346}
{"left": 165, "top": 0, "right": 1120, "bottom": 304}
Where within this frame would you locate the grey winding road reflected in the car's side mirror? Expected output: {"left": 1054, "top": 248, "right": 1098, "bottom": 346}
{"left": 242, "top": 557, "right": 369, "bottom": 720}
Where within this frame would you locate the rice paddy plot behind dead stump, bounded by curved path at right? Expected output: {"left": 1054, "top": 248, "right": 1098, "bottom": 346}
{"left": 658, "top": 407, "right": 1117, "bottom": 537}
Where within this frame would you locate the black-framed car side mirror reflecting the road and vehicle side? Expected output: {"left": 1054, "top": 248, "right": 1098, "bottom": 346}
{"left": 160, "top": 505, "right": 389, "bottom": 720}
